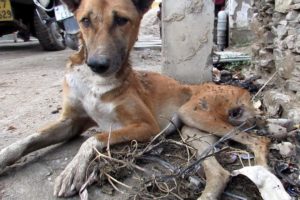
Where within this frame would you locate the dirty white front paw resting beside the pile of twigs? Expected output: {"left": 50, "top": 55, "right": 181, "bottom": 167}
{"left": 54, "top": 156, "right": 87, "bottom": 197}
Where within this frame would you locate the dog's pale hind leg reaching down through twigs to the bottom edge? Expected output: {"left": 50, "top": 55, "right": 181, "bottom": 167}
{"left": 182, "top": 126, "right": 230, "bottom": 200}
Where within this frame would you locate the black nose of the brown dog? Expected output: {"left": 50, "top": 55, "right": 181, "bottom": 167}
{"left": 87, "top": 56, "right": 110, "bottom": 74}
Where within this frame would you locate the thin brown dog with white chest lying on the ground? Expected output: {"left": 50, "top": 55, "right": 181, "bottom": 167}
{"left": 0, "top": 0, "right": 267, "bottom": 197}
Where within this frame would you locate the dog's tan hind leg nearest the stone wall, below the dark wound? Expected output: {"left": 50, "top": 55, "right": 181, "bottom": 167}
{"left": 178, "top": 101, "right": 269, "bottom": 166}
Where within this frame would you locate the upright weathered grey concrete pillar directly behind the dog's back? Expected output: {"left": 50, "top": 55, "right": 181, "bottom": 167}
{"left": 162, "top": 0, "right": 214, "bottom": 83}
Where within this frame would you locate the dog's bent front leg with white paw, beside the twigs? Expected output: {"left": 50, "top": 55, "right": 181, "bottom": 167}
{"left": 54, "top": 123, "right": 159, "bottom": 197}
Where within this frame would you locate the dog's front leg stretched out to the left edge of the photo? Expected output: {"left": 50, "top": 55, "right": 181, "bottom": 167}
{"left": 0, "top": 118, "right": 88, "bottom": 174}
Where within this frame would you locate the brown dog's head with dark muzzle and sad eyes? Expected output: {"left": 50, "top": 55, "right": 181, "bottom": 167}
{"left": 62, "top": 0, "right": 153, "bottom": 76}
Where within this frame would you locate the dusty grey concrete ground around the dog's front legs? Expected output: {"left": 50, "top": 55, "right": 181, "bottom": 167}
{"left": 0, "top": 41, "right": 161, "bottom": 200}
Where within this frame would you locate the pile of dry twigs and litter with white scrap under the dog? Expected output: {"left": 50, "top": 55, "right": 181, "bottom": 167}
{"left": 80, "top": 109, "right": 300, "bottom": 200}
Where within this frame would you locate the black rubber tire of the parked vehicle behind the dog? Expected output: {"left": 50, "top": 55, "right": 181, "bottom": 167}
{"left": 33, "top": 10, "right": 66, "bottom": 51}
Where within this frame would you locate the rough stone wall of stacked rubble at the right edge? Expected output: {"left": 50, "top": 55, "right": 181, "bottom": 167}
{"left": 251, "top": 0, "right": 300, "bottom": 123}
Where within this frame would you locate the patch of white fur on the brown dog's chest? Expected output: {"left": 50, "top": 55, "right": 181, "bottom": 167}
{"left": 66, "top": 65, "right": 121, "bottom": 131}
